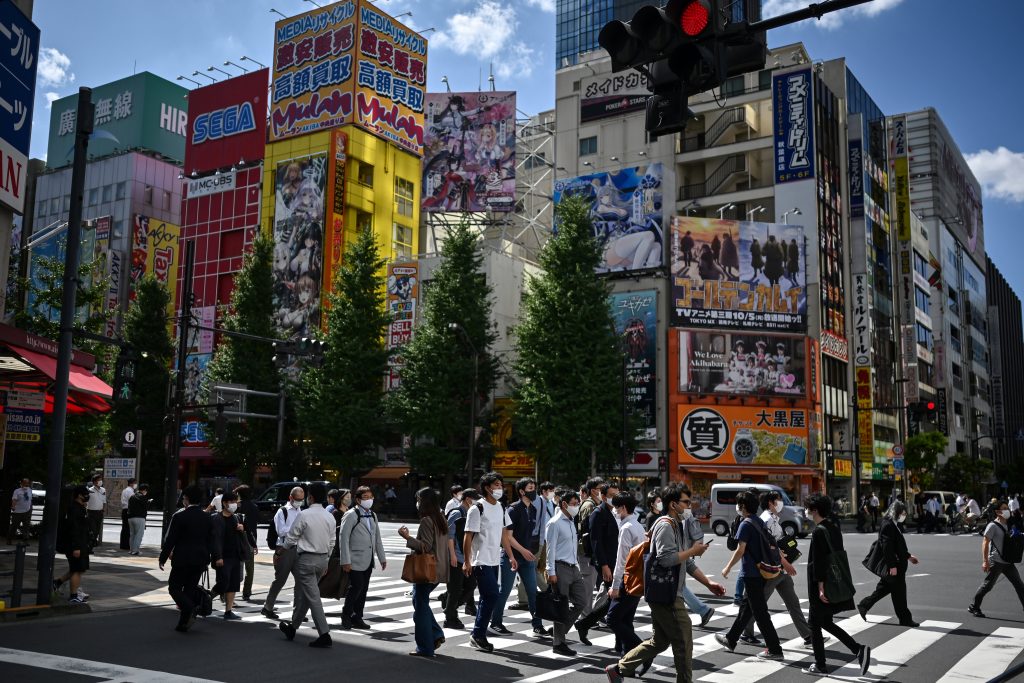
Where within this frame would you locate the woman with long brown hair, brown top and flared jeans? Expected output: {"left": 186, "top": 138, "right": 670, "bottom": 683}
{"left": 398, "top": 486, "right": 449, "bottom": 657}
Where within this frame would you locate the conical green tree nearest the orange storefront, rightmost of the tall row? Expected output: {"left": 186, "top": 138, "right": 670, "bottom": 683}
{"left": 515, "top": 194, "right": 623, "bottom": 481}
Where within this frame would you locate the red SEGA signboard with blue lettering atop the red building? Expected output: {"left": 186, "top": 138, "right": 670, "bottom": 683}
{"left": 184, "top": 69, "right": 270, "bottom": 174}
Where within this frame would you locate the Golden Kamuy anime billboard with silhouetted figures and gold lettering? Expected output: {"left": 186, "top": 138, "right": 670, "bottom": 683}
{"left": 672, "top": 216, "right": 807, "bottom": 333}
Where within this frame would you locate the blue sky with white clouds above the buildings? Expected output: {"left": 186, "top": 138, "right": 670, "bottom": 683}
{"left": 19, "top": 0, "right": 1024, "bottom": 295}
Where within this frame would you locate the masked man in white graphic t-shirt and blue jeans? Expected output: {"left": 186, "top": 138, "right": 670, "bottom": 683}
{"left": 462, "top": 472, "right": 519, "bottom": 652}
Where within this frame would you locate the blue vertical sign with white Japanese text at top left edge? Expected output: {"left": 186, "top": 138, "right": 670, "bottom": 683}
{"left": 0, "top": 0, "right": 39, "bottom": 213}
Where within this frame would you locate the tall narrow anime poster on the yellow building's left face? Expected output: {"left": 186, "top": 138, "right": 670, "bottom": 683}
{"left": 273, "top": 154, "right": 327, "bottom": 338}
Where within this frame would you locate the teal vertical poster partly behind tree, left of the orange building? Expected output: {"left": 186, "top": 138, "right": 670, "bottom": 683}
{"left": 609, "top": 290, "right": 657, "bottom": 441}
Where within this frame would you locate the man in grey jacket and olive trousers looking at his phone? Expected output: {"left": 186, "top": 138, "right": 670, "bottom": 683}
{"left": 604, "top": 482, "right": 725, "bottom": 683}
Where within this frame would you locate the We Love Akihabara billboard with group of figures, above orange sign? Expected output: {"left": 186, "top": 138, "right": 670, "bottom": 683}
{"left": 679, "top": 330, "right": 808, "bottom": 398}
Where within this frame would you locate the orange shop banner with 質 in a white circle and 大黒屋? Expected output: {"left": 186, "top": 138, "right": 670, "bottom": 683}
{"left": 677, "top": 405, "right": 809, "bottom": 467}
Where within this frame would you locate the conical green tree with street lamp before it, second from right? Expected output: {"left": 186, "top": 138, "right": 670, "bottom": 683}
{"left": 388, "top": 222, "right": 498, "bottom": 475}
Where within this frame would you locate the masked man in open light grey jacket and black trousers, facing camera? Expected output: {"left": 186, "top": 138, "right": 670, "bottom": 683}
{"left": 338, "top": 486, "right": 387, "bottom": 631}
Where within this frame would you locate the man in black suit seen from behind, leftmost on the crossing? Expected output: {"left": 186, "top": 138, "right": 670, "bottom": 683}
{"left": 160, "top": 484, "right": 220, "bottom": 633}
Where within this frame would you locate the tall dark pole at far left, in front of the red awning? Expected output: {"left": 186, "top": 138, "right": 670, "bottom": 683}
{"left": 36, "top": 88, "right": 93, "bottom": 605}
